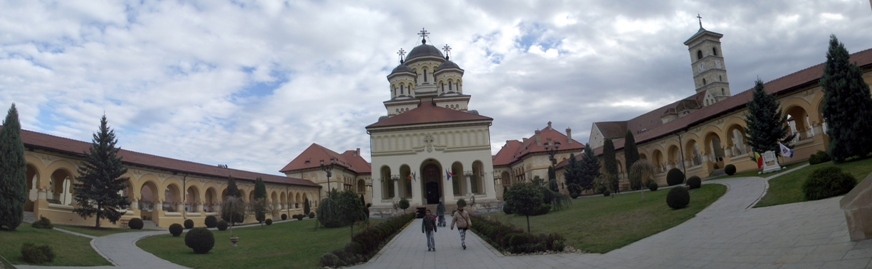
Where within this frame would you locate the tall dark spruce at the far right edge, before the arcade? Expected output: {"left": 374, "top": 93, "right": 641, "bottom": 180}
{"left": 820, "top": 35, "right": 872, "bottom": 162}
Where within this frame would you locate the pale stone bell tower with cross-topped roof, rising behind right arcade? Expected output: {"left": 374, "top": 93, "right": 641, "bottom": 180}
{"left": 684, "top": 15, "right": 731, "bottom": 106}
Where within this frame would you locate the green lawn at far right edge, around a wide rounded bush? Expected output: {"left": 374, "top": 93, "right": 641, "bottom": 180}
{"left": 754, "top": 158, "right": 872, "bottom": 207}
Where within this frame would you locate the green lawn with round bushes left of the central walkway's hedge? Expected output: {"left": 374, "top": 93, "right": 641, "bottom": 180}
{"left": 136, "top": 220, "right": 380, "bottom": 268}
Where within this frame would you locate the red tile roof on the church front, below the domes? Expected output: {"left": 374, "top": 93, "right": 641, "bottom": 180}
{"left": 366, "top": 100, "right": 494, "bottom": 130}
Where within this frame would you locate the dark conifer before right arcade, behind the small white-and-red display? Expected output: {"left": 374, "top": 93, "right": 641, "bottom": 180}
{"left": 744, "top": 79, "right": 796, "bottom": 154}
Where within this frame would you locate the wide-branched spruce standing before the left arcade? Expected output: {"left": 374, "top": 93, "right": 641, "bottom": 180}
{"left": 73, "top": 115, "right": 130, "bottom": 228}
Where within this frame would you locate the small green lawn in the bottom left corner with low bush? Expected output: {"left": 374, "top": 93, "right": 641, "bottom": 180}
{"left": 0, "top": 223, "right": 112, "bottom": 266}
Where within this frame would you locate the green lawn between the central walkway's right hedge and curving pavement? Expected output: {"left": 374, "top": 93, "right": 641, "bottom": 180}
{"left": 491, "top": 184, "right": 727, "bottom": 253}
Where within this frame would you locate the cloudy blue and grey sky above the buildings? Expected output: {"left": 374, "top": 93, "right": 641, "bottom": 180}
{"left": 0, "top": 0, "right": 872, "bottom": 174}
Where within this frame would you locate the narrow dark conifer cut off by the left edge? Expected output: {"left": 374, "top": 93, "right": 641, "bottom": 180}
{"left": 0, "top": 104, "right": 27, "bottom": 230}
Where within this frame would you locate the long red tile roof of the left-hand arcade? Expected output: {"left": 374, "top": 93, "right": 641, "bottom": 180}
{"left": 14, "top": 127, "right": 320, "bottom": 187}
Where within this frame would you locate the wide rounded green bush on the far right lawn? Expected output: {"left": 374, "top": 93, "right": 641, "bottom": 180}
{"left": 802, "top": 166, "right": 857, "bottom": 200}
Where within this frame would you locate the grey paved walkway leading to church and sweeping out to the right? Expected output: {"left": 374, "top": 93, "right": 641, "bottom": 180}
{"left": 357, "top": 177, "right": 872, "bottom": 268}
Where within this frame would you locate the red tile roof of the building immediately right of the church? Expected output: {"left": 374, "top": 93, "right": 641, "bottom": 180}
{"left": 493, "top": 123, "right": 584, "bottom": 166}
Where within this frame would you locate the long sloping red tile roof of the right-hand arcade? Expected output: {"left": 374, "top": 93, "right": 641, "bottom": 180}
{"left": 594, "top": 49, "right": 872, "bottom": 155}
